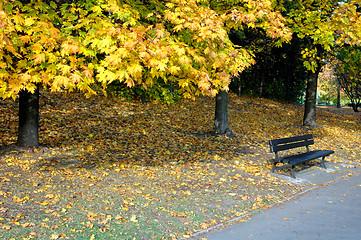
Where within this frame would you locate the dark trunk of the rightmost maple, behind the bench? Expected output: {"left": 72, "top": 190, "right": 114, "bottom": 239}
{"left": 303, "top": 67, "right": 320, "bottom": 127}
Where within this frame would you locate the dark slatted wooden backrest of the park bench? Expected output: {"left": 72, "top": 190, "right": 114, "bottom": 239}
{"left": 269, "top": 134, "right": 314, "bottom": 153}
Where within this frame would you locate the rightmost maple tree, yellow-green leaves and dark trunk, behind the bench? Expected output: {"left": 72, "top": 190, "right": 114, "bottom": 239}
{"left": 278, "top": 0, "right": 361, "bottom": 126}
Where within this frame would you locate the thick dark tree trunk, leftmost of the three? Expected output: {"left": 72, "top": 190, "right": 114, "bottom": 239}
{"left": 17, "top": 86, "right": 39, "bottom": 148}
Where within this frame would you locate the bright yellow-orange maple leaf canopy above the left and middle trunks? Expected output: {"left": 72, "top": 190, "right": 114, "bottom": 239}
{"left": 0, "top": 0, "right": 285, "bottom": 98}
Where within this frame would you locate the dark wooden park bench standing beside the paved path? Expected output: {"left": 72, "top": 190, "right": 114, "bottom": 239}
{"left": 269, "top": 134, "right": 334, "bottom": 178}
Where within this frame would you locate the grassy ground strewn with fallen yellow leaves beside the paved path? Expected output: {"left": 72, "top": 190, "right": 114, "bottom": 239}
{"left": 0, "top": 93, "right": 361, "bottom": 239}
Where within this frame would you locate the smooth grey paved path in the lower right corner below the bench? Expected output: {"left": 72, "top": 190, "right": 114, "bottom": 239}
{"left": 194, "top": 163, "right": 361, "bottom": 240}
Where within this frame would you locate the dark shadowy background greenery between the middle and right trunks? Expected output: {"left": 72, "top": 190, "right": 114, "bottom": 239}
{"left": 231, "top": 30, "right": 307, "bottom": 102}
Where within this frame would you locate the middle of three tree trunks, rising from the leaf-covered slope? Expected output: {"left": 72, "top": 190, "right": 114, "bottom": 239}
{"left": 213, "top": 91, "right": 233, "bottom": 137}
